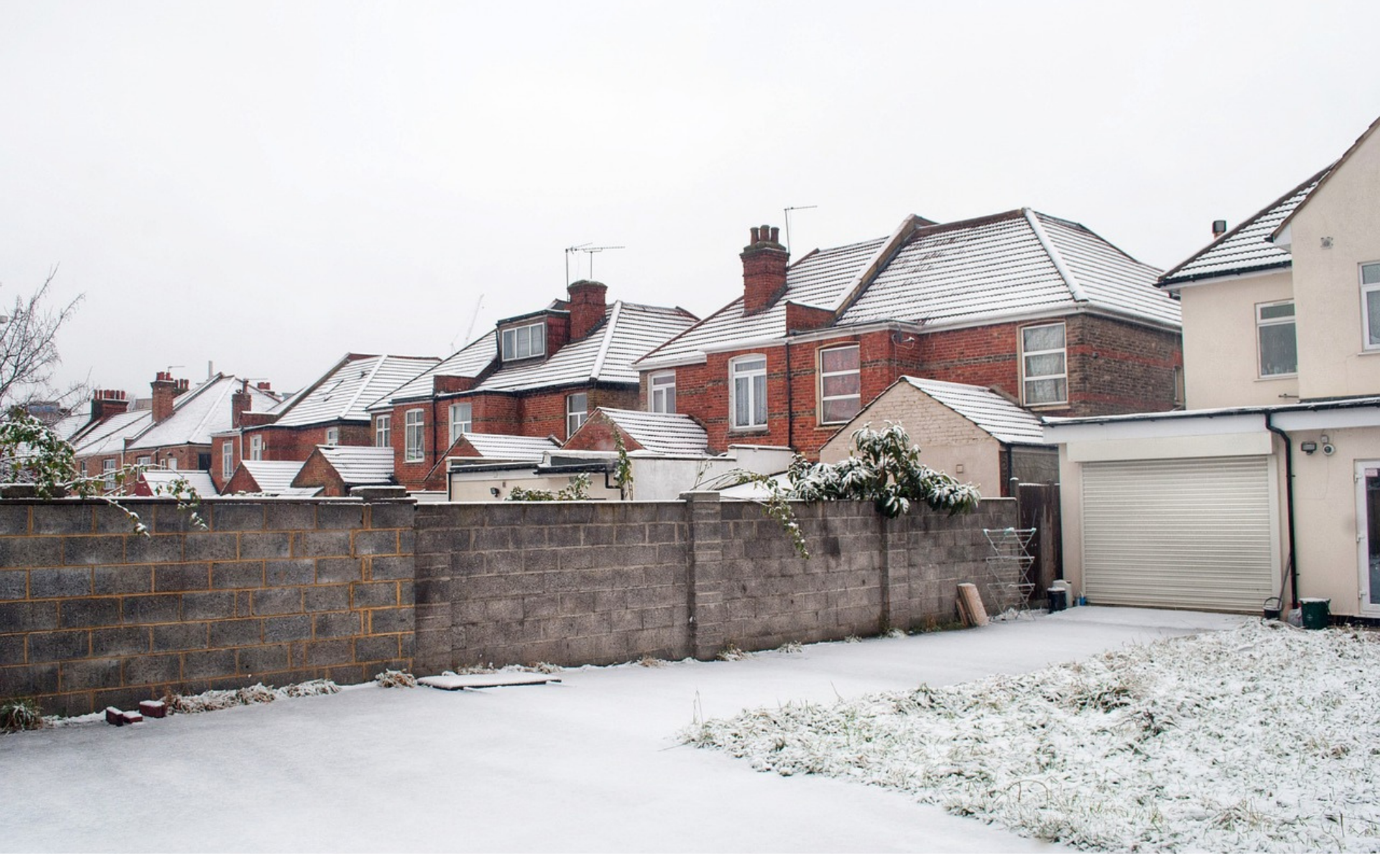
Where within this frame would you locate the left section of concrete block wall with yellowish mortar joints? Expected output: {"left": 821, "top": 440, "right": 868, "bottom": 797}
{"left": 0, "top": 498, "right": 414, "bottom": 714}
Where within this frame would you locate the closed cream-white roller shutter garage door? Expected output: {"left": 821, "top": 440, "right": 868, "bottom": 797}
{"left": 1082, "top": 456, "right": 1277, "bottom": 612}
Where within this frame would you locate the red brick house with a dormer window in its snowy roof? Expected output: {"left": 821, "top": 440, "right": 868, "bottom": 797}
{"left": 368, "top": 282, "right": 696, "bottom": 492}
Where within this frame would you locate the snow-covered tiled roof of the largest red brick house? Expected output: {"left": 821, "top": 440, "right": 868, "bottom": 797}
{"left": 638, "top": 209, "right": 1180, "bottom": 369}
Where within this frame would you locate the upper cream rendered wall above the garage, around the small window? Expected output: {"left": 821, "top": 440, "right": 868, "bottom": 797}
{"left": 1180, "top": 269, "right": 1303, "bottom": 410}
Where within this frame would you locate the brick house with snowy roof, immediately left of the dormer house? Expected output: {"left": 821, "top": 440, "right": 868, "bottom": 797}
{"left": 210, "top": 353, "right": 439, "bottom": 490}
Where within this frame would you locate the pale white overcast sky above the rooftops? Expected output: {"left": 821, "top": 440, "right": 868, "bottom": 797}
{"left": 0, "top": 0, "right": 1380, "bottom": 395}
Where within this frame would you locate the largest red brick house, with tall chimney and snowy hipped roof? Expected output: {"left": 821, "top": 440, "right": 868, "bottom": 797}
{"left": 635, "top": 210, "right": 1181, "bottom": 458}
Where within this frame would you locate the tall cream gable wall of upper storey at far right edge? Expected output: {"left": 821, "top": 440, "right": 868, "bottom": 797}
{"left": 1289, "top": 129, "right": 1380, "bottom": 399}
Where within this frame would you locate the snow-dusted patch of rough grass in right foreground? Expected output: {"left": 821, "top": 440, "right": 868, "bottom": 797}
{"left": 683, "top": 621, "right": 1380, "bottom": 852}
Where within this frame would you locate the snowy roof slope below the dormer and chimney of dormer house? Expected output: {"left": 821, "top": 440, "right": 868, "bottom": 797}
{"left": 475, "top": 301, "right": 694, "bottom": 392}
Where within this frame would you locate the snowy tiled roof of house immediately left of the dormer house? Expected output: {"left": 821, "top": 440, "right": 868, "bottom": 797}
{"left": 275, "top": 353, "right": 437, "bottom": 427}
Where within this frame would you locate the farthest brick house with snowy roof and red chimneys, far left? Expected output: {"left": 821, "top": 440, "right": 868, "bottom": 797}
{"left": 70, "top": 371, "right": 280, "bottom": 486}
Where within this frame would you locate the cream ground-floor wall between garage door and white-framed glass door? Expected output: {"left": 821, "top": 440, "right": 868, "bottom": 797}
{"left": 1290, "top": 428, "right": 1380, "bottom": 614}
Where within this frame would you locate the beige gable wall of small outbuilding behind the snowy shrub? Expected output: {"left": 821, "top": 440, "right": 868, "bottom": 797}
{"left": 820, "top": 382, "right": 1002, "bottom": 497}
